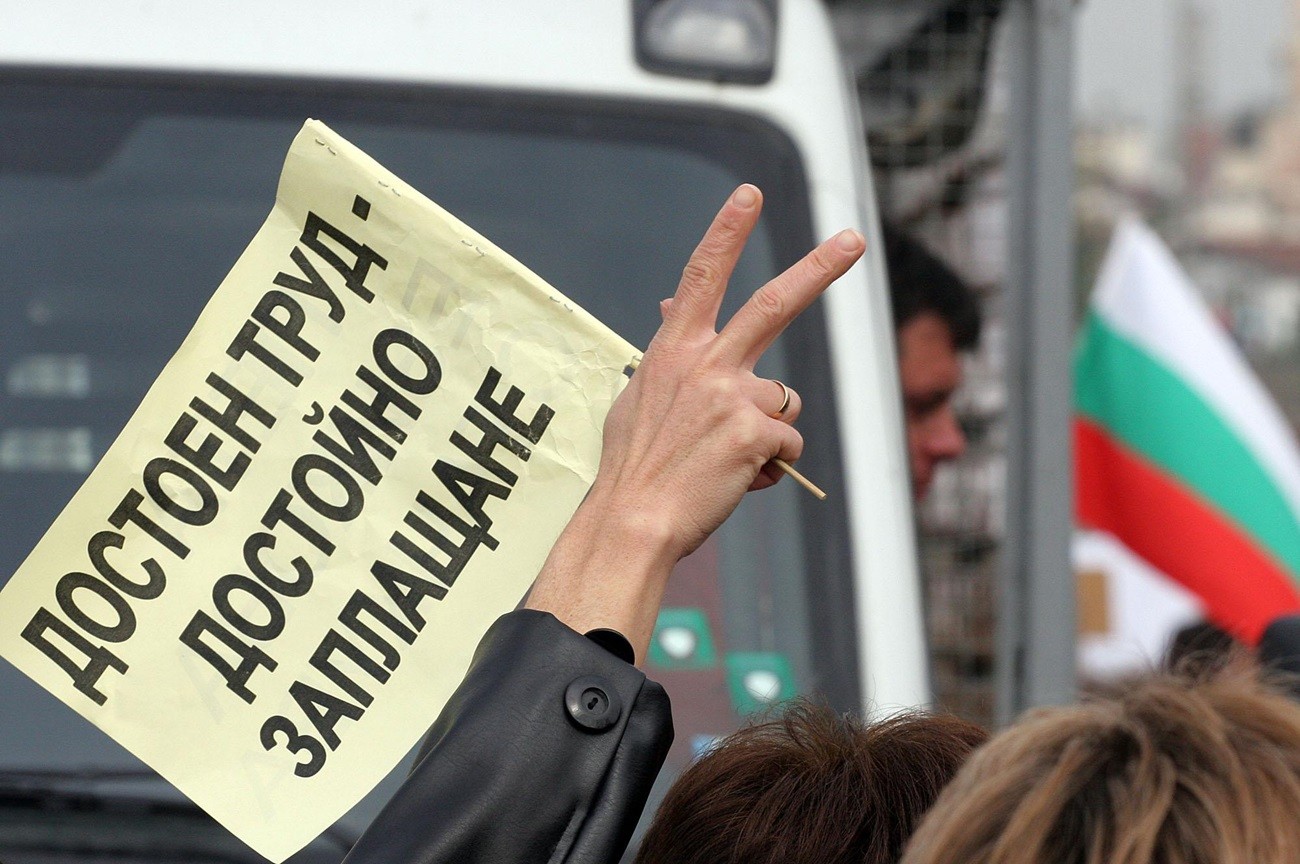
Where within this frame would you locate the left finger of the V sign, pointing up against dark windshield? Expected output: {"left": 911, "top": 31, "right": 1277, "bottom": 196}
{"left": 660, "top": 183, "right": 763, "bottom": 338}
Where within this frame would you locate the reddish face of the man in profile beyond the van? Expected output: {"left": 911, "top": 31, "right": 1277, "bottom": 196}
{"left": 897, "top": 312, "right": 966, "bottom": 502}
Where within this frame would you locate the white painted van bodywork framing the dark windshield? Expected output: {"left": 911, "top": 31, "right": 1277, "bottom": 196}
{"left": 0, "top": 0, "right": 931, "bottom": 847}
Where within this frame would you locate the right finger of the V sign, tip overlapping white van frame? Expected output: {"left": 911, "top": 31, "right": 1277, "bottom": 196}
{"left": 716, "top": 229, "right": 866, "bottom": 369}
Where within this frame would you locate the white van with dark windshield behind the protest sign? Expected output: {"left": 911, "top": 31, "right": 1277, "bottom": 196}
{"left": 0, "top": 0, "right": 930, "bottom": 864}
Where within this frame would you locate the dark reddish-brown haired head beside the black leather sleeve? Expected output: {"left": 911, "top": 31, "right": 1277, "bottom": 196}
{"left": 636, "top": 702, "right": 988, "bottom": 864}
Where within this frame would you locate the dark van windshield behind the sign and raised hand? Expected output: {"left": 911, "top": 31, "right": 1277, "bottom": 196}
{"left": 0, "top": 71, "right": 857, "bottom": 864}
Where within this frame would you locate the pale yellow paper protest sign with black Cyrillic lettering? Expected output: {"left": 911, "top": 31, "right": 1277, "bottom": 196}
{"left": 0, "top": 121, "right": 636, "bottom": 861}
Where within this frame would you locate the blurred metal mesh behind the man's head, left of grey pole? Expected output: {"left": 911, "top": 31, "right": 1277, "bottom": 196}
{"left": 836, "top": 0, "right": 1006, "bottom": 726}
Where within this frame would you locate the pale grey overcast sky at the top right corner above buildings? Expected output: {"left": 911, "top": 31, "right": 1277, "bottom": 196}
{"left": 1075, "top": 0, "right": 1294, "bottom": 133}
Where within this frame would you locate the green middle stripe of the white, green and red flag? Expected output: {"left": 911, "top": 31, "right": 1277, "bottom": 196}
{"left": 1074, "top": 311, "right": 1300, "bottom": 579}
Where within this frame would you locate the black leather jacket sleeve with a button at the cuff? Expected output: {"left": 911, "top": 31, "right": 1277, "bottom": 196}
{"left": 346, "top": 609, "right": 672, "bottom": 864}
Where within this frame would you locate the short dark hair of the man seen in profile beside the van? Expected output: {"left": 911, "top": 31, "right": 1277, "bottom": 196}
{"left": 880, "top": 222, "right": 980, "bottom": 351}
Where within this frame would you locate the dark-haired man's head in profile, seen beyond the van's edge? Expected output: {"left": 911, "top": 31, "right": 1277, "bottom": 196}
{"left": 881, "top": 223, "right": 980, "bottom": 500}
